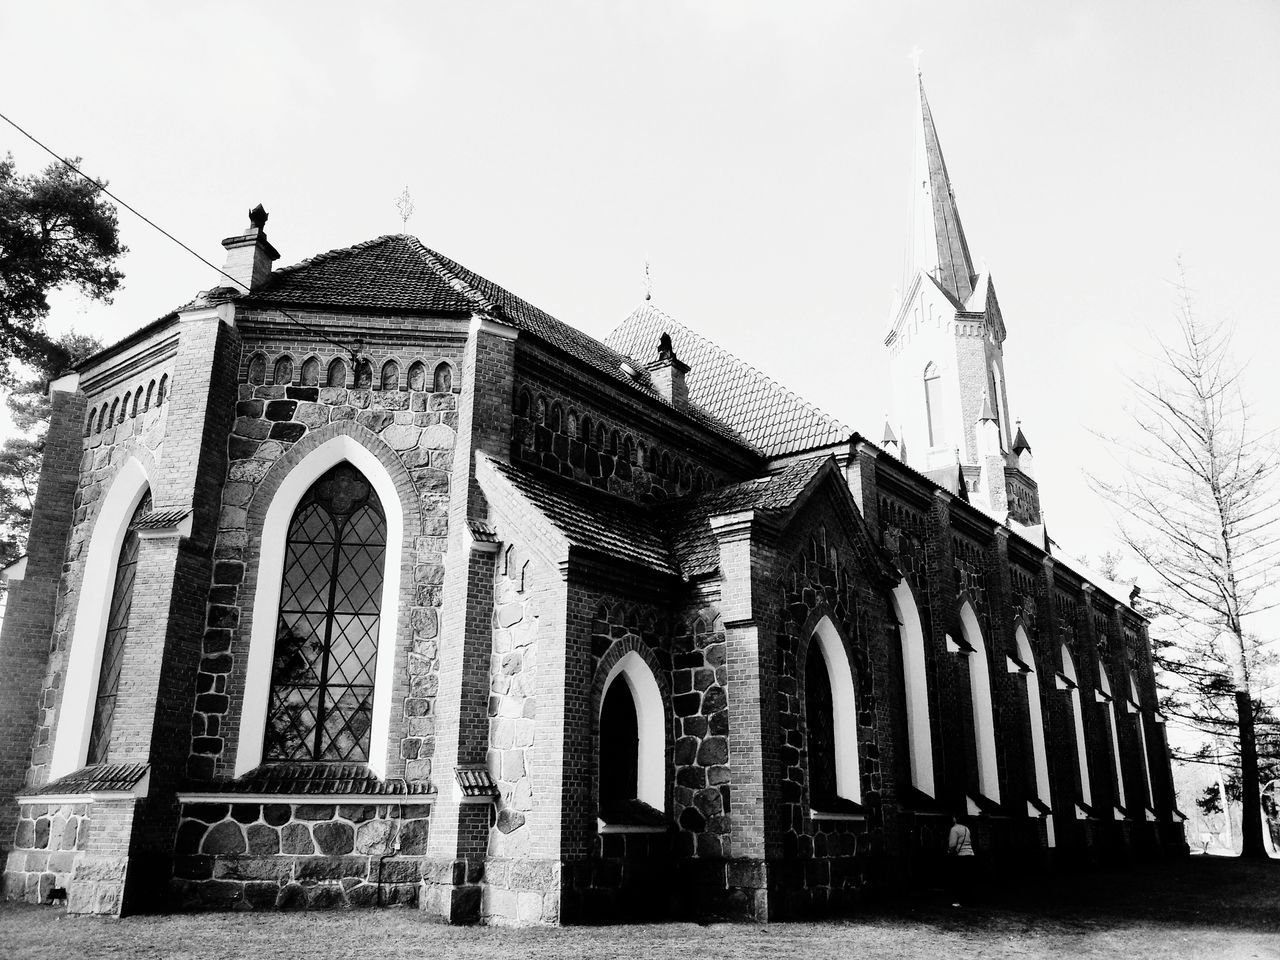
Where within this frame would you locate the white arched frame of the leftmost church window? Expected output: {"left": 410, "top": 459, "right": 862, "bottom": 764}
{"left": 49, "top": 457, "right": 151, "bottom": 780}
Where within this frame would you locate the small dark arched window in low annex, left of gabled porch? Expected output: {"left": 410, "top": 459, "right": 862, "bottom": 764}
{"left": 599, "top": 650, "right": 666, "bottom": 823}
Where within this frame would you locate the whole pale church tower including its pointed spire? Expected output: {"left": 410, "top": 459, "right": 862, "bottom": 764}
{"left": 884, "top": 74, "right": 1042, "bottom": 532}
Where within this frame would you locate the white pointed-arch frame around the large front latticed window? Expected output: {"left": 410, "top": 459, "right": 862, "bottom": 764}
{"left": 236, "top": 435, "right": 404, "bottom": 777}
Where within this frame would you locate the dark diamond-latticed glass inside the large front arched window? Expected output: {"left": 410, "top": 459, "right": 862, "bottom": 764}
{"left": 262, "top": 463, "right": 387, "bottom": 762}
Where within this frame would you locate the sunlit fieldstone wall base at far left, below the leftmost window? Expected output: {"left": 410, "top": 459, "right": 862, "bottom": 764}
{"left": 4, "top": 803, "right": 90, "bottom": 904}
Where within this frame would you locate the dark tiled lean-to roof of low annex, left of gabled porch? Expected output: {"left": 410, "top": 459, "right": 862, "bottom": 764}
{"left": 480, "top": 456, "right": 680, "bottom": 576}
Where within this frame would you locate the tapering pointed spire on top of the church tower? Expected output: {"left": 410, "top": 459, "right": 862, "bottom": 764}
{"left": 904, "top": 74, "right": 975, "bottom": 305}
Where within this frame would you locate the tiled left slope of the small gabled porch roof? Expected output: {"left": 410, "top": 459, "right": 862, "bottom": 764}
{"left": 657, "top": 457, "right": 829, "bottom": 579}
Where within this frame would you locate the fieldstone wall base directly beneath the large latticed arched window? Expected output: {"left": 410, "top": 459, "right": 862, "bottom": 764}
{"left": 172, "top": 801, "right": 431, "bottom": 910}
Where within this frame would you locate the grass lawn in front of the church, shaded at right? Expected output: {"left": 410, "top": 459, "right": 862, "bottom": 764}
{"left": 0, "top": 856, "right": 1280, "bottom": 960}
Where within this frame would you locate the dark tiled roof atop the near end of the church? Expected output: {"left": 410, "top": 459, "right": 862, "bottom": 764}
{"left": 241, "top": 234, "right": 742, "bottom": 443}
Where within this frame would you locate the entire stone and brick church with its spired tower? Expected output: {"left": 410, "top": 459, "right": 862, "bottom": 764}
{"left": 0, "top": 77, "right": 1185, "bottom": 924}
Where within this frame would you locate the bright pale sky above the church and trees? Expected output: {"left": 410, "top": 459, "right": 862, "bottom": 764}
{"left": 0, "top": 0, "right": 1280, "bottom": 624}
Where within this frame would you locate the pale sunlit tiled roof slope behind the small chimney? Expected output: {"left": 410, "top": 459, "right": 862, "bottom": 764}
{"left": 605, "top": 303, "right": 854, "bottom": 457}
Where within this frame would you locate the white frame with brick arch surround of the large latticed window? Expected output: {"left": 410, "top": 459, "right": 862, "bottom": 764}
{"left": 236, "top": 432, "right": 416, "bottom": 777}
